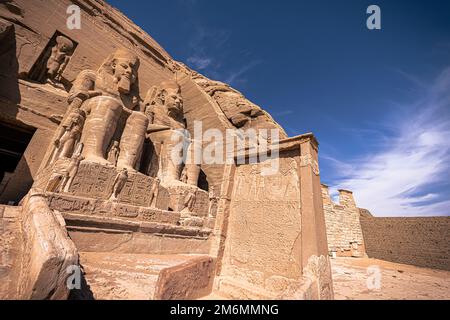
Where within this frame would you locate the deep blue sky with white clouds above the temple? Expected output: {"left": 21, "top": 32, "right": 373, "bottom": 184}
{"left": 108, "top": 0, "right": 450, "bottom": 216}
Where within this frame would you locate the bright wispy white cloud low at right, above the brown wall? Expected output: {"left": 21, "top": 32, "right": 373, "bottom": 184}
{"left": 322, "top": 68, "right": 450, "bottom": 216}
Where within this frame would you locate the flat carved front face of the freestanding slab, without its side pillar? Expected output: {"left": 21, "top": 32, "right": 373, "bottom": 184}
{"left": 224, "top": 151, "right": 301, "bottom": 289}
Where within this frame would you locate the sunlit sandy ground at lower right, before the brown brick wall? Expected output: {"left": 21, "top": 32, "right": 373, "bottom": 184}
{"left": 331, "top": 258, "right": 450, "bottom": 300}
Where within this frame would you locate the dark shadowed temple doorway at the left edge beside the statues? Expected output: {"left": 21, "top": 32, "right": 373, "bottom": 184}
{"left": 0, "top": 121, "right": 35, "bottom": 204}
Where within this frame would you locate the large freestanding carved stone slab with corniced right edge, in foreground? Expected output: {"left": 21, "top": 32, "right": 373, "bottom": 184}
{"left": 211, "top": 134, "right": 333, "bottom": 299}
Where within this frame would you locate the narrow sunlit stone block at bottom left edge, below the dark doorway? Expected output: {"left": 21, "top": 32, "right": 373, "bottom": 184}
{"left": 0, "top": 205, "right": 22, "bottom": 300}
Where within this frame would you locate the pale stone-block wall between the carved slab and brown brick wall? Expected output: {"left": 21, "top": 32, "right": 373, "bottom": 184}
{"left": 322, "top": 185, "right": 364, "bottom": 256}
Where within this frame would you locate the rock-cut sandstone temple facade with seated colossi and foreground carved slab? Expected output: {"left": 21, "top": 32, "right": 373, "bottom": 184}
{"left": 0, "top": 0, "right": 333, "bottom": 299}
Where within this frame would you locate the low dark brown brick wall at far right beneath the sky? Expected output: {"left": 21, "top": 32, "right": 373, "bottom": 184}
{"left": 361, "top": 212, "right": 450, "bottom": 270}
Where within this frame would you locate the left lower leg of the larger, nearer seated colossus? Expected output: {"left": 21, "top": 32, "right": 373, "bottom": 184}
{"left": 81, "top": 96, "right": 122, "bottom": 165}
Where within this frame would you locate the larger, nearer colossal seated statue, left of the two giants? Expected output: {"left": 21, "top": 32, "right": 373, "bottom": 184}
{"left": 69, "top": 49, "right": 148, "bottom": 171}
